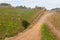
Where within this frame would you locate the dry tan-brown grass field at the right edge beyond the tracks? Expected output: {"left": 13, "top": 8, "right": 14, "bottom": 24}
{"left": 47, "top": 12, "right": 60, "bottom": 31}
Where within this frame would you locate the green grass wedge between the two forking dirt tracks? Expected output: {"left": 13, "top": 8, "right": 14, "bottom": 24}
{"left": 41, "top": 24, "right": 55, "bottom": 40}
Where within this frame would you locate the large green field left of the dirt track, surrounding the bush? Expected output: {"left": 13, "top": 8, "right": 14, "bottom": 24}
{"left": 0, "top": 8, "right": 37, "bottom": 40}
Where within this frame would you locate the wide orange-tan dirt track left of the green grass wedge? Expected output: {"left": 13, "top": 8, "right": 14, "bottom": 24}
{"left": 6, "top": 13, "right": 53, "bottom": 40}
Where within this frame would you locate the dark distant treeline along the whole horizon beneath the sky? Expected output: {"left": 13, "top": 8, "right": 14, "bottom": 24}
{"left": 0, "top": 3, "right": 60, "bottom": 12}
